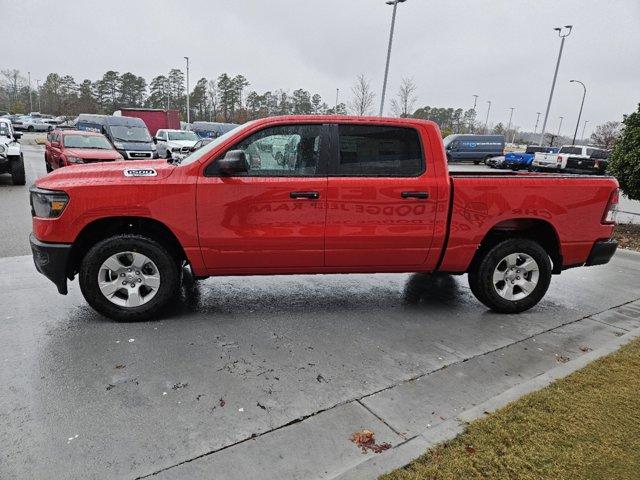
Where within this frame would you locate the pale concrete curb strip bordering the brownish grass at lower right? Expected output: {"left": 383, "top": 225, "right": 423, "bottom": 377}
{"left": 332, "top": 326, "right": 640, "bottom": 480}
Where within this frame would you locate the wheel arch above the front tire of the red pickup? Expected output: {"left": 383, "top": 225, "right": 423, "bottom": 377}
{"left": 67, "top": 216, "right": 188, "bottom": 278}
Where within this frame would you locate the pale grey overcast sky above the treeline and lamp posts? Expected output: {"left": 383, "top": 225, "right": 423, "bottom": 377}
{"left": 5, "top": 0, "right": 640, "bottom": 135}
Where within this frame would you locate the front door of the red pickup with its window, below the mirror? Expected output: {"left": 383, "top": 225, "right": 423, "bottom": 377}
{"left": 197, "top": 124, "right": 329, "bottom": 273}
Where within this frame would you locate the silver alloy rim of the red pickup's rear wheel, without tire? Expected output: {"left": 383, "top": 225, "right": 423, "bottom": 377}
{"left": 492, "top": 253, "right": 540, "bottom": 301}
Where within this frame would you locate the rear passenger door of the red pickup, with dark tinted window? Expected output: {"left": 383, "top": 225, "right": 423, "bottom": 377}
{"left": 325, "top": 124, "right": 437, "bottom": 268}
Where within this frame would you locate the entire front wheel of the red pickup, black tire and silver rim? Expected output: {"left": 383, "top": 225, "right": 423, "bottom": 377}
{"left": 79, "top": 234, "right": 180, "bottom": 321}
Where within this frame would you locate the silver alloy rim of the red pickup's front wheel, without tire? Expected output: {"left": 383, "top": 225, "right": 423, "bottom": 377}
{"left": 98, "top": 252, "right": 160, "bottom": 308}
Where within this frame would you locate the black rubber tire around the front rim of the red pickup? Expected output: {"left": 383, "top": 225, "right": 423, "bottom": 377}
{"left": 79, "top": 234, "right": 181, "bottom": 322}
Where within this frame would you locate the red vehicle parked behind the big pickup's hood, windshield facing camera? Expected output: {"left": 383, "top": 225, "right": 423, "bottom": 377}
{"left": 44, "top": 130, "right": 123, "bottom": 172}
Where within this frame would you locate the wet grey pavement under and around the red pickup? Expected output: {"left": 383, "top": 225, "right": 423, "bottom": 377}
{"left": 0, "top": 135, "right": 640, "bottom": 479}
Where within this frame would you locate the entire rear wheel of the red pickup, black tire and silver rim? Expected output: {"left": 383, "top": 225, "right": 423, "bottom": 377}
{"left": 469, "top": 238, "right": 551, "bottom": 313}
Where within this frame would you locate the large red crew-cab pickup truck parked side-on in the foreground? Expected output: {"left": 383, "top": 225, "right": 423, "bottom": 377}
{"left": 31, "top": 116, "right": 618, "bottom": 320}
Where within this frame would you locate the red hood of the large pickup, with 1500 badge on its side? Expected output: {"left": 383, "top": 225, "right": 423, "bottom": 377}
{"left": 36, "top": 160, "right": 176, "bottom": 190}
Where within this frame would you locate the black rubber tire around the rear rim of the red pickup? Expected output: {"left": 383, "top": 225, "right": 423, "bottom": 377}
{"left": 468, "top": 238, "right": 551, "bottom": 313}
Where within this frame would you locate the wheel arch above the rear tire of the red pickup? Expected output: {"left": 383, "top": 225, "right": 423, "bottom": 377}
{"left": 471, "top": 218, "right": 562, "bottom": 273}
